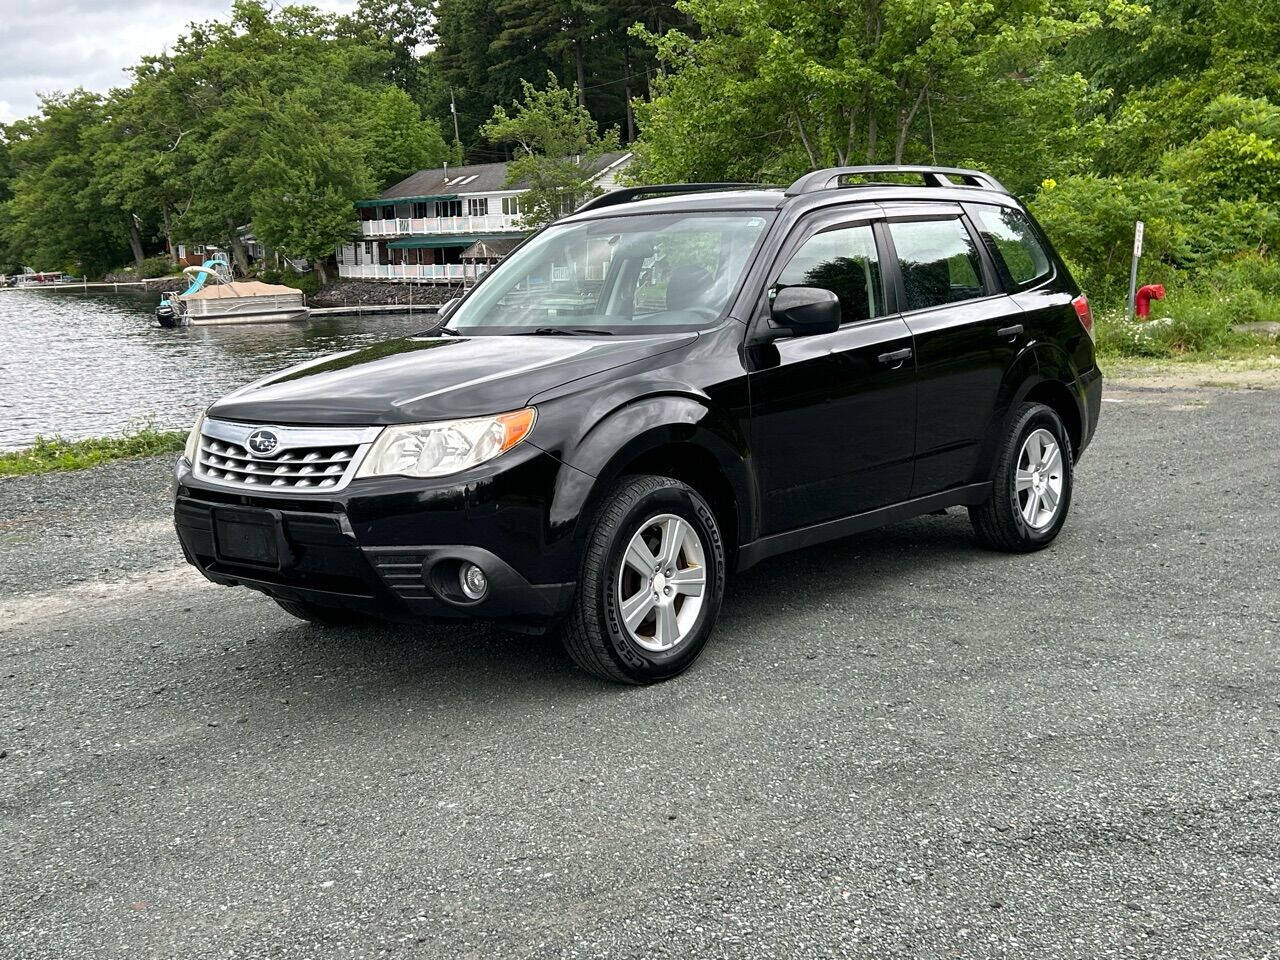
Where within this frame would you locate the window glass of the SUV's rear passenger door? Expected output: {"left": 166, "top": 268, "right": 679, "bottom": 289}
{"left": 888, "top": 218, "right": 984, "bottom": 310}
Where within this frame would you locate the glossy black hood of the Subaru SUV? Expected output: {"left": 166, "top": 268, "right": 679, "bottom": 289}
{"left": 209, "top": 333, "right": 698, "bottom": 425}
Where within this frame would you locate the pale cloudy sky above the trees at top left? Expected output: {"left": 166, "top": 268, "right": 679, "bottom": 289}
{"left": 0, "top": 0, "right": 356, "bottom": 123}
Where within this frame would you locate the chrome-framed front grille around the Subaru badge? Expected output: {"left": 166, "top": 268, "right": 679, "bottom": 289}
{"left": 195, "top": 420, "right": 378, "bottom": 493}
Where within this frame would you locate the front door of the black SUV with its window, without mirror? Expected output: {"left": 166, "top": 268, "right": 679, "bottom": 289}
{"left": 749, "top": 218, "right": 915, "bottom": 534}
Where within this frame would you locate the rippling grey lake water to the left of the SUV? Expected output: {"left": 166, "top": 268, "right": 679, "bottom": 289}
{"left": 0, "top": 289, "right": 429, "bottom": 449}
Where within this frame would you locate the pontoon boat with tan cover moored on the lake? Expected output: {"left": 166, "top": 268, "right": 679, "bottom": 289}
{"left": 155, "top": 259, "right": 311, "bottom": 326}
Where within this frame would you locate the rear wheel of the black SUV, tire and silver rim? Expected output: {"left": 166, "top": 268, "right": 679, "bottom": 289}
{"left": 969, "top": 403, "right": 1074, "bottom": 553}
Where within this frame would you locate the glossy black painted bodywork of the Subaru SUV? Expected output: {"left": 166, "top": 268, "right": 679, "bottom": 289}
{"left": 177, "top": 187, "right": 1101, "bottom": 622}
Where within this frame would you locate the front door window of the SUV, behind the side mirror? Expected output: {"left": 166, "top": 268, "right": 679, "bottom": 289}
{"left": 773, "top": 224, "right": 884, "bottom": 324}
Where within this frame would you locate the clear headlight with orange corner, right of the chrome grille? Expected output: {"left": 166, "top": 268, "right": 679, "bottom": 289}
{"left": 356, "top": 407, "right": 535, "bottom": 477}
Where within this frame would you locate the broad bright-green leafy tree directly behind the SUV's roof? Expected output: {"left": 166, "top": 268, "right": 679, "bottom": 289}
{"left": 632, "top": 0, "right": 1140, "bottom": 190}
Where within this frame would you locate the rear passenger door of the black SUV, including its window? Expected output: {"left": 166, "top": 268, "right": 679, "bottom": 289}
{"left": 883, "top": 204, "right": 1023, "bottom": 497}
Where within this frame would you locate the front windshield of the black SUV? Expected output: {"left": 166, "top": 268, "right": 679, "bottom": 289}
{"left": 445, "top": 211, "right": 767, "bottom": 335}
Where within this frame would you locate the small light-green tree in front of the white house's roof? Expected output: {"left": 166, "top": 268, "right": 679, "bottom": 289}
{"left": 481, "top": 74, "right": 620, "bottom": 227}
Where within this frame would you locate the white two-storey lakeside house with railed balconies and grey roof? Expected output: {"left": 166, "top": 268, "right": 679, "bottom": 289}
{"left": 338, "top": 152, "right": 631, "bottom": 283}
